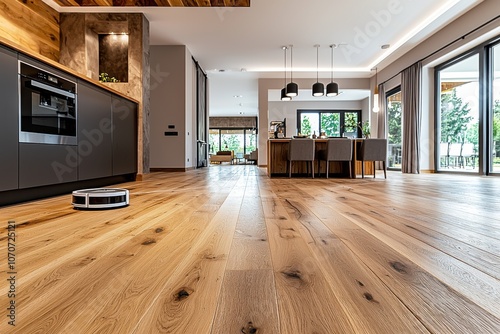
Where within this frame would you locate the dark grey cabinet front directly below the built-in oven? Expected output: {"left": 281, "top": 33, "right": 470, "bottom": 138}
{"left": 19, "top": 143, "right": 80, "bottom": 188}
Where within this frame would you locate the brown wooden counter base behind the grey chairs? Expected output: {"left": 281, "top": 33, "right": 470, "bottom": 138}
{"left": 267, "top": 138, "right": 373, "bottom": 178}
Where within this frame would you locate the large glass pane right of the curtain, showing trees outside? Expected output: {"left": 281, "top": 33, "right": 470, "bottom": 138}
{"left": 437, "top": 53, "right": 480, "bottom": 172}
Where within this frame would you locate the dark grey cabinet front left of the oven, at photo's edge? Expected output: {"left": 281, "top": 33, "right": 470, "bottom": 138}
{"left": 0, "top": 46, "right": 19, "bottom": 191}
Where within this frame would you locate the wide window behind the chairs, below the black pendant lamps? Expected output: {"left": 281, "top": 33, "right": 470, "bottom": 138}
{"left": 297, "top": 110, "right": 361, "bottom": 137}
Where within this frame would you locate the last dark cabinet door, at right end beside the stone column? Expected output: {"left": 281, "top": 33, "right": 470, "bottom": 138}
{"left": 112, "top": 95, "right": 137, "bottom": 175}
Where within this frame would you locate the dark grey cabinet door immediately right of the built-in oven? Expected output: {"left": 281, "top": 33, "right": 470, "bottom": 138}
{"left": 77, "top": 81, "right": 114, "bottom": 180}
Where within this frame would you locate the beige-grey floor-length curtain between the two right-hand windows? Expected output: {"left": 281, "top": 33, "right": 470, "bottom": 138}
{"left": 401, "top": 62, "right": 422, "bottom": 174}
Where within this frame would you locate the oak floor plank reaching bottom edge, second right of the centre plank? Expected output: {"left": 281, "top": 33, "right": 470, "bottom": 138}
{"left": 262, "top": 186, "right": 429, "bottom": 333}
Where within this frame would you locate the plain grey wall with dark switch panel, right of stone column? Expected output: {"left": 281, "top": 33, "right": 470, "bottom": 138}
{"left": 150, "top": 46, "right": 196, "bottom": 169}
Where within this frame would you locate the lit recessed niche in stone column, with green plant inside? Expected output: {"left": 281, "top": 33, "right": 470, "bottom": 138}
{"left": 98, "top": 33, "right": 128, "bottom": 82}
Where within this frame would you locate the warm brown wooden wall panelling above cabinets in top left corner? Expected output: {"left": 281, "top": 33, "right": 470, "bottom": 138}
{"left": 0, "top": 0, "right": 60, "bottom": 61}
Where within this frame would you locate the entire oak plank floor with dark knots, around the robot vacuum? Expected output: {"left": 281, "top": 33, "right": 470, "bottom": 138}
{"left": 0, "top": 165, "right": 500, "bottom": 334}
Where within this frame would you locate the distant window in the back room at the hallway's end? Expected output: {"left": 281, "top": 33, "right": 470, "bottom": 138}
{"left": 209, "top": 129, "right": 257, "bottom": 154}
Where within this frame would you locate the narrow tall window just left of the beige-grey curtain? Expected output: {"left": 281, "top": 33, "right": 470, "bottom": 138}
{"left": 386, "top": 87, "right": 402, "bottom": 169}
